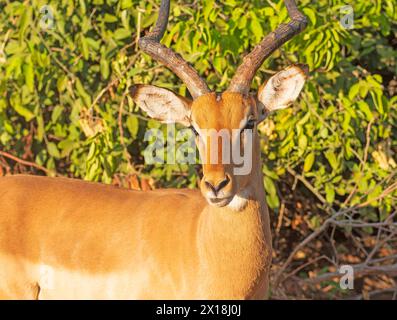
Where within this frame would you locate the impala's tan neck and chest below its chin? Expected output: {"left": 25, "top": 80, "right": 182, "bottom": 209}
{"left": 197, "top": 139, "right": 272, "bottom": 298}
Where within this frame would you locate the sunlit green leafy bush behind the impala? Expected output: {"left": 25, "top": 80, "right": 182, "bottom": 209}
{"left": 0, "top": 0, "right": 397, "bottom": 224}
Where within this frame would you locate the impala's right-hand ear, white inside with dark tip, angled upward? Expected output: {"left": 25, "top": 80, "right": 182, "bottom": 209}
{"left": 258, "top": 65, "right": 307, "bottom": 111}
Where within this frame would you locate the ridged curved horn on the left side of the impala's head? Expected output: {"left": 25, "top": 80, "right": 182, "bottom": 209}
{"left": 139, "top": 0, "right": 211, "bottom": 98}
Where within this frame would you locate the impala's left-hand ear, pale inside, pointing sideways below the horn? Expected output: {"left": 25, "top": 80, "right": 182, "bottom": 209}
{"left": 130, "top": 85, "right": 192, "bottom": 126}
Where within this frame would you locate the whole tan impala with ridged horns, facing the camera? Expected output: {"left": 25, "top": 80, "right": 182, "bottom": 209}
{"left": 0, "top": 0, "right": 307, "bottom": 299}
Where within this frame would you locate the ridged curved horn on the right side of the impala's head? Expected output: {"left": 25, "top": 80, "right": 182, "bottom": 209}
{"left": 228, "top": 0, "right": 307, "bottom": 94}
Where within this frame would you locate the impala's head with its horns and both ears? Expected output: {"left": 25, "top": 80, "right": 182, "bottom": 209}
{"left": 131, "top": 0, "right": 308, "bottom": 207}
